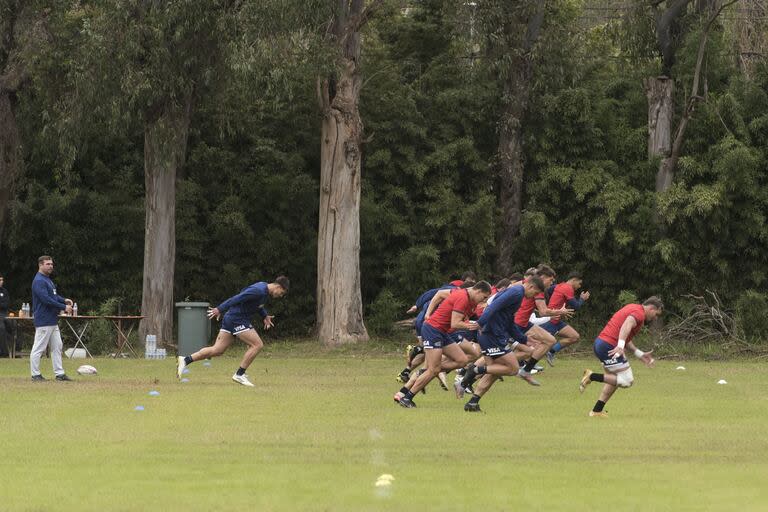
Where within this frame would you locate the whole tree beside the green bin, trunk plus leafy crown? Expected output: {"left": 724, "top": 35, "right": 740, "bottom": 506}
{"left": 78, "top": 0, "right": 240, "bottom": 344}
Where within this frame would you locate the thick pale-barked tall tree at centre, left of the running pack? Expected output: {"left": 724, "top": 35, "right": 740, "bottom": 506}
{"left": 317, "top": 0, "right": 383, "bottom": 345}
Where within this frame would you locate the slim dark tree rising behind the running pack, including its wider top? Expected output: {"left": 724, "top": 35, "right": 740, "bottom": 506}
{"left": 478, "top": 0, "right": 547, "bottom": 275}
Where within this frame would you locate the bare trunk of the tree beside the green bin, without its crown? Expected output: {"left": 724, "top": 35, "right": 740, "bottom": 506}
{"left": 139, "top": 100, "right": 191, "bottom": 346}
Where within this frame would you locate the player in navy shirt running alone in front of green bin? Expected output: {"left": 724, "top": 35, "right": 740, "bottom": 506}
{"left": 176, "top": 276, "right": 290, "bottom": 387}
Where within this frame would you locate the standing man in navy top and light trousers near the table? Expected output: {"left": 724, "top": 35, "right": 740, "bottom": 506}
{"left": 29, "top": 256, "right": 72, "bottom": 381}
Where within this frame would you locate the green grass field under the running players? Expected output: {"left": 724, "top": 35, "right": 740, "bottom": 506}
{"left": 0, "top": 346, "right": 768, "bottom": 512}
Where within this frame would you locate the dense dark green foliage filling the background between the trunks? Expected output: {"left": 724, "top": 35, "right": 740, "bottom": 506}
{"left": 0, "top": 0, "right": 768, "bottom": 340}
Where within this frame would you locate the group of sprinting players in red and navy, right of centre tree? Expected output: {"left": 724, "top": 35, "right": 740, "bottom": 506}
{"left": 394, "top": 264, "right": 663, "bottom": 417}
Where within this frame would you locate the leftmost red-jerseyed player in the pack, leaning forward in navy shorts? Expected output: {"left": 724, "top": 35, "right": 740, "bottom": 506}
{"left": 395, "top": 281, "right": 491, "bottom": 408}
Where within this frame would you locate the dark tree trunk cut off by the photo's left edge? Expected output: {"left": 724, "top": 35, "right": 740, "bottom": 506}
{"left": 0, "top": 90, "right": 22, "bottom": 241}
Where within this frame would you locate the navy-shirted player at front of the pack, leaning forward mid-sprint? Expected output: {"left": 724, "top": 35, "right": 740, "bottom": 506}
{"left": 456, "top": 276, "right": 545, "bottom": 412}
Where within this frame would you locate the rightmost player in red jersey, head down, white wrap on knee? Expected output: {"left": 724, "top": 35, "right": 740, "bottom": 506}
{"left": 579, "top": 297, "right": 664, "bottom": 416}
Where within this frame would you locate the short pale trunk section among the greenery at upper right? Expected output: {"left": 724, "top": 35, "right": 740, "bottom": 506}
{"left": 644, "top": 76, "right": 675, "bottom": 192}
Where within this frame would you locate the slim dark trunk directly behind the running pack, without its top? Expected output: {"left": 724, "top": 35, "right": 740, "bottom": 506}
{"left": 496, "top": 69, "right": 531, "bottom": 275}
